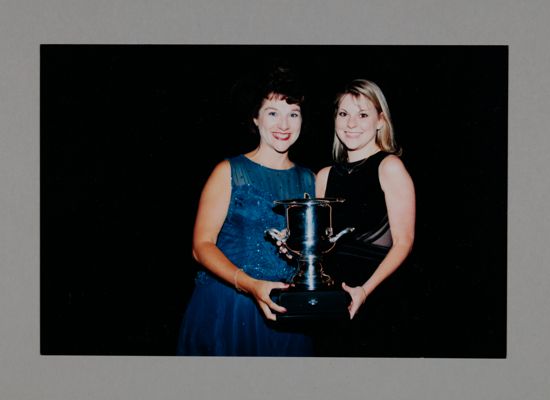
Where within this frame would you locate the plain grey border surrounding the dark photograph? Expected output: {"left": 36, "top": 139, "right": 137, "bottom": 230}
{"left": 0, "top": 0, "right": 550, "bottom": 400}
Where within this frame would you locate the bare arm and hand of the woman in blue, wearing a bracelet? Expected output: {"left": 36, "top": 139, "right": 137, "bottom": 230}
{"left": 193, "top": 161, "right": 288, "bottom": 320}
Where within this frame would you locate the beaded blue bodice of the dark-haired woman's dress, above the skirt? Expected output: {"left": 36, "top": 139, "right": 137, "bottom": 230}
{"left": 196, "top": 155, "right": 315, "bottom": 284}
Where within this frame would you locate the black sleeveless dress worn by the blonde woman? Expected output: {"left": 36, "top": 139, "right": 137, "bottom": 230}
{"left": 315, "top": 151, "right": 406, "bottom": 357}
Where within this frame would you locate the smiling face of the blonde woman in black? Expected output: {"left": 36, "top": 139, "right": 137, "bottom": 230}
{"left": 335, "top": 94, "right": 384, "bottom": 161}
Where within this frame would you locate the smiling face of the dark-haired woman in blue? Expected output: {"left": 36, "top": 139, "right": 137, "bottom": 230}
{"left": 254, "top": 95, "right": 302, "bottom": 153}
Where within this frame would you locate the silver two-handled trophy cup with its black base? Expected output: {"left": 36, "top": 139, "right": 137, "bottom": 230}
{"left": 266, "top": 193, "right": 354, "bottom": 318}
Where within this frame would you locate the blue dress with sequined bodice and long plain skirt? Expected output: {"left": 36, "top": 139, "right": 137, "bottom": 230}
{"left": 177, "top": 155, "right": 315, "bottom": 356}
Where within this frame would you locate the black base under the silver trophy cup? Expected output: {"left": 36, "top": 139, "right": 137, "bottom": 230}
{"left": 271, "top": 288, "right": 351, "bottom": 322}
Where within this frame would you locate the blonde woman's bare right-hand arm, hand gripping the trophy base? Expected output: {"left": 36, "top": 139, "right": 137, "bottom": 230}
{"left": 344, "top": 155, "right": 416, "bottom": 318}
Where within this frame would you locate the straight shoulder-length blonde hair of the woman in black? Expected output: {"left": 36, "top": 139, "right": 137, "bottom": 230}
{"left": 332, "top": 79, "right": 401, "bottom": 162}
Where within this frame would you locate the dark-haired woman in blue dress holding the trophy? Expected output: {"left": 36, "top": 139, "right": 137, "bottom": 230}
{"left": 177, "top": 68, "right": 315, "bottom": 356}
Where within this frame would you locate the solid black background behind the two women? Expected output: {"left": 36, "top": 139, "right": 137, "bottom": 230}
{"left": 40, "top": 45, "right": 508, "bottom": 358}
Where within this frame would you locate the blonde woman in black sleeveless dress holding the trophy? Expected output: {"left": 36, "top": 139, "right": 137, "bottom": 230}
{"left": 316, "top": 79, "right": 415, "bottom": 356}
